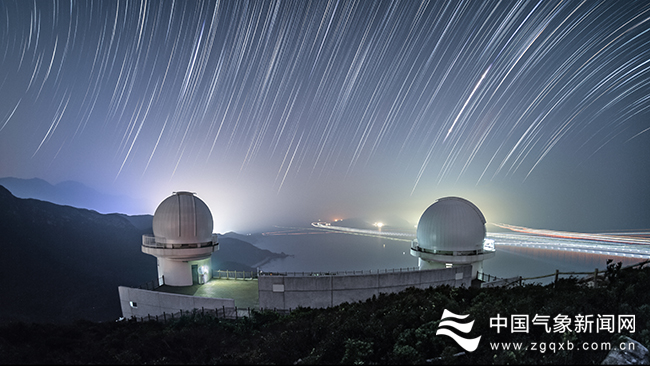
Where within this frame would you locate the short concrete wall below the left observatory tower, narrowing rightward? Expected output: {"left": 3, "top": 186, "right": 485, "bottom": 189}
{"left": 118, "top": 286, "right": 235, "bottom": 318}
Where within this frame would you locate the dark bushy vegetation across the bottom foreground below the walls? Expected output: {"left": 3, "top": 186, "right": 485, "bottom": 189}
{"left": 0, "top": 265, "right": 650, "bottom": 364}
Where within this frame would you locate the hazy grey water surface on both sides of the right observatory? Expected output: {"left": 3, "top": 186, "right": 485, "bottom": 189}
{"left": 247, "top": 228, "right": 650, "bottom": 283}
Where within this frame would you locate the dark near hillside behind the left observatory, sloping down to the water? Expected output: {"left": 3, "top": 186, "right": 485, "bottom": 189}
{"left": 0, "top": 186, "right": 285, "bottom": 323}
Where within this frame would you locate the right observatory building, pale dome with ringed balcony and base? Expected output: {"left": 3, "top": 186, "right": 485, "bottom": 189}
{"left": 411, "top": 197, "right": 495, "bottom": 278}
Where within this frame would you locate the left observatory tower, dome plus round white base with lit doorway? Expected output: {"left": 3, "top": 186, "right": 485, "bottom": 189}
{"left": 142, "top": 192, "right": 219, "bottom": 286}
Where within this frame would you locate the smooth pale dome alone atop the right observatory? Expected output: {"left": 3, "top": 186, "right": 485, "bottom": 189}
{"left": 417, "top": 197, "right": 485, "bottom": 252}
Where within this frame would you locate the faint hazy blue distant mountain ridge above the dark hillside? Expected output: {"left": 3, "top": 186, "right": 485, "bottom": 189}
{"left": 0, "top": 177, "right": 146, "bottom": 214}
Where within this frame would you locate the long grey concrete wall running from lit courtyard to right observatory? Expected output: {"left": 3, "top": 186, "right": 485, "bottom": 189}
{"left": 258, "top": 266, "right": 472, "bottom": 309}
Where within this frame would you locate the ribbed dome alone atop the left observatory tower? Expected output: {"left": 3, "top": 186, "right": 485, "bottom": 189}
{"left": 153, "top": 192, "right": 213, "bottom": 244}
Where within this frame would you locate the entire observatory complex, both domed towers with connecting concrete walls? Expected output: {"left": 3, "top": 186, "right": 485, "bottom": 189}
{"left": 118, "top": 192, "right": 495, "bottom": 321}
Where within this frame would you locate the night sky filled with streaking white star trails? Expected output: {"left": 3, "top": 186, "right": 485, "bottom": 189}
{"left": 0, "top": 0, "right": 650, "bottom": 232}
